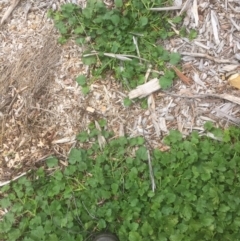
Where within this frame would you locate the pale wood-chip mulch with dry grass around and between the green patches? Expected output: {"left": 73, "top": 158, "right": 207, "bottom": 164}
{"left": 0, "top": 0, "right": 240, "bottom": 185}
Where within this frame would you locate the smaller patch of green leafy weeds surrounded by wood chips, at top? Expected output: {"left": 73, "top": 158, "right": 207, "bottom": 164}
{"left": 49, "top": 0, "right": 185, "bottom": 88}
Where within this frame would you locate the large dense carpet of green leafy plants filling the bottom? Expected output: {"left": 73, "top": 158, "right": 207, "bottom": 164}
{"left": 0, "top": 121, "right": 240, "bottom": 241}
